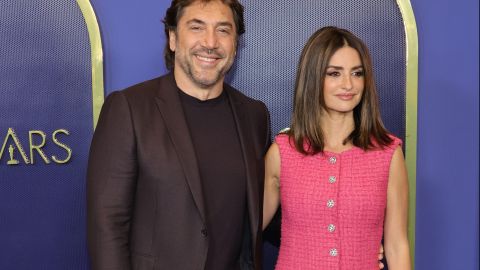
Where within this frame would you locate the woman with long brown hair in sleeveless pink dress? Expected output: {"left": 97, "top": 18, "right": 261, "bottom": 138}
{"left": 263, "top": 27, "right": 411, "bottom": 270}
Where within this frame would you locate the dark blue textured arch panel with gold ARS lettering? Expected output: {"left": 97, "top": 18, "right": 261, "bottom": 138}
{"left": 0, "top": 0, "right": 93, "bottom": 270}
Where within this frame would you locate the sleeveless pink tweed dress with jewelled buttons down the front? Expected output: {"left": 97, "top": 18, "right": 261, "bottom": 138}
{"left": 275, "top": 134, "right": 401, "bottom": 270}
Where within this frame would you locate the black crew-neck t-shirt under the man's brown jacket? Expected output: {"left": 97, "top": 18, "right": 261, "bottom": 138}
{"left": 179, "top": 90, "right": 246, "bottom": 270}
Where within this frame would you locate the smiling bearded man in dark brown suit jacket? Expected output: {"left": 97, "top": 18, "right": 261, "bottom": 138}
{"left": 87, "top": 0, "right": 270, "bottom": 270}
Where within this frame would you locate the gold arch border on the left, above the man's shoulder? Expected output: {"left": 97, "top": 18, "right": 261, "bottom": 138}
{"left": 77, "top": 0, "right": 104, "bottom": 129}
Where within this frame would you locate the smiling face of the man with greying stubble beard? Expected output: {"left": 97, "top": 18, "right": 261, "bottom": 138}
{"left": 169, "top": 1, "right": 237, "bottom": 90}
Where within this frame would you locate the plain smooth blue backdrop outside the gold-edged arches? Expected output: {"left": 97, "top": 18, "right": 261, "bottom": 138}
{"left": 91, "top": 0, "right": 479, "bottom": 270}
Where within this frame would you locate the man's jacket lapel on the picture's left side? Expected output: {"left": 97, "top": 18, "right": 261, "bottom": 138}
{"left": 156, "top": 74, "right": 206, "bottom": 223}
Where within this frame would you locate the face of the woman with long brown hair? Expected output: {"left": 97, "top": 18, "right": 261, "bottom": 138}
{"left": 323, "top": 46, "right": 365, "bottom": 113}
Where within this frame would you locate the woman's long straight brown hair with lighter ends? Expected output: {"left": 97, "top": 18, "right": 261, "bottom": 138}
{"left": 287, "top": 26, "right": 392, "bottom": 155}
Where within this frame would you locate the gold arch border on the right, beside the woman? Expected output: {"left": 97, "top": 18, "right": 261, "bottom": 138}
{"left": 397, "top": 0, "right": 418, "bottom": 269}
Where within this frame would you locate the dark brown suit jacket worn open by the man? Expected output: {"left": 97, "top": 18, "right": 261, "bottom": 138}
{"left": 87, "top": 74, "right": 270, "bottom": 270}
